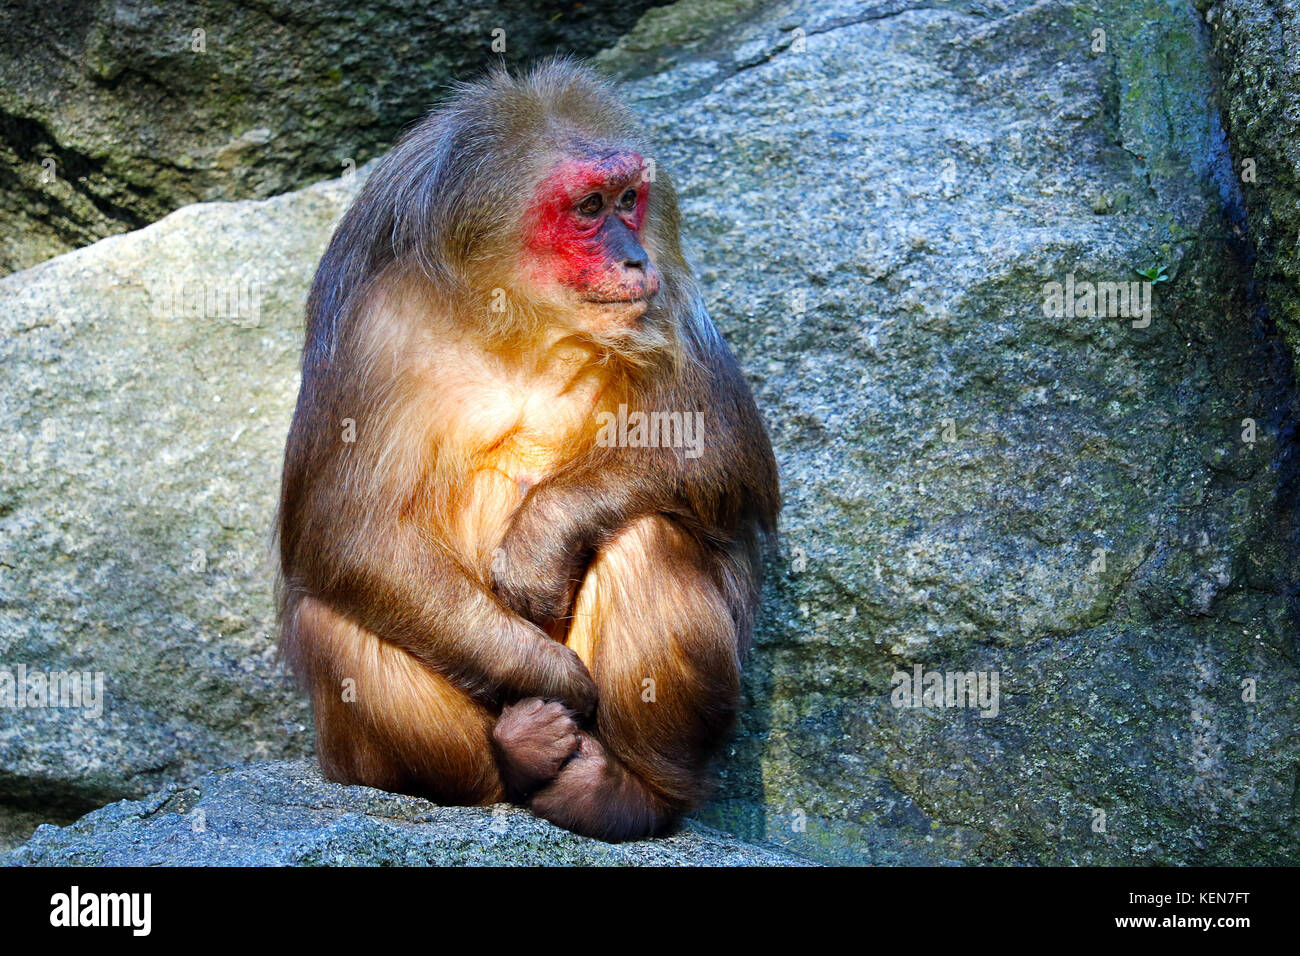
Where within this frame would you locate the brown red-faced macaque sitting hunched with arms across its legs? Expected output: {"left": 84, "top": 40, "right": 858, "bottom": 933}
{"left": 278, "top": 60, "right": 780, "bottom": 840}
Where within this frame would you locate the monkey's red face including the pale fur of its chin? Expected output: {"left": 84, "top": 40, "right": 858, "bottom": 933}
{"left": 520, "top": 147, "right": 660, "bottom": 332}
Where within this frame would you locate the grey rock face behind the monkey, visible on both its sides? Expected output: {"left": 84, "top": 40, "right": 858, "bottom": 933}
{"left": 0, "top": 0, "right": 1300, "bottom": 864}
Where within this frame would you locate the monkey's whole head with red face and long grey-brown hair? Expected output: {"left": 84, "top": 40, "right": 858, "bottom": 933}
{"left": 330, "top": 60, "right": 696, "bottom": 358}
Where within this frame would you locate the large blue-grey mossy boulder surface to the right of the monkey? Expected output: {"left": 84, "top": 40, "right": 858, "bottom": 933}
{"left": 603, "top": 3, "right": 1300, "bottom": 864}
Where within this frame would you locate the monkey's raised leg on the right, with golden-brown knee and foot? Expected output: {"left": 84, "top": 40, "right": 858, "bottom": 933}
{"left": 530, "top": 516, "right": 740, "bottom": 840}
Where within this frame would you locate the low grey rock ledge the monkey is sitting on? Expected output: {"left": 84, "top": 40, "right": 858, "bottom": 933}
{"left": 0, "top": 761, "right": 809, "bottom": 866}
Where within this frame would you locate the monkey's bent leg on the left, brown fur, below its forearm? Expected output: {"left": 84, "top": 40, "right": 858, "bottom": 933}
{"left": 283, "top": 597, "right": 503, "bottom": 804}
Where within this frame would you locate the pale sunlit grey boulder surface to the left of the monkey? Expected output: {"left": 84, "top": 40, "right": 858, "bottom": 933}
{"left": 0, "top": 169, "right": 365, "bottom": 837}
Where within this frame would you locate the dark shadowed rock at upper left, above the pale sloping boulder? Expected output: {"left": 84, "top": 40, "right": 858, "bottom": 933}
{"left": 0, "top": 0, "right": 660, "bottom": 274}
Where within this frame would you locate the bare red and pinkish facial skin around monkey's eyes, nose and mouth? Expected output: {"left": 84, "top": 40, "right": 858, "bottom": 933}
{"left": 525, "top": 152, "right": 659, "bottom": 303}
